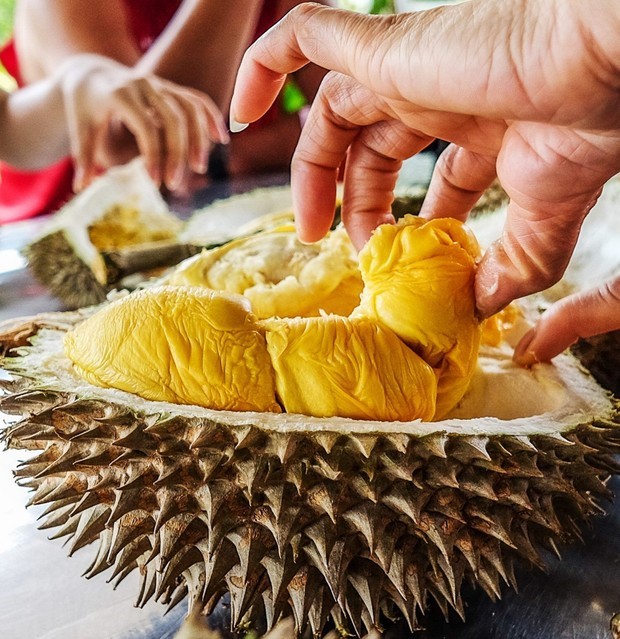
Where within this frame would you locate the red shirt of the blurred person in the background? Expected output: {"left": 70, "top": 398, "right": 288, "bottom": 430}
{"left": 0, "top": 0, "right": 277, "bottom": 224}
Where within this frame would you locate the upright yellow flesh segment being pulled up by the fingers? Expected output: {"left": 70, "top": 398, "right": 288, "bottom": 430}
{"left": 354, "top": 216, "right": 481, "bottom": 419}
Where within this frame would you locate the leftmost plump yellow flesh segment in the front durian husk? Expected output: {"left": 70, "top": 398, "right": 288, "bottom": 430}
{"left": 65, "top": 286, "right": 280, "bottom": 412}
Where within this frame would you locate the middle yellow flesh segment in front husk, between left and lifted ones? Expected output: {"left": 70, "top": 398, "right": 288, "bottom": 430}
{"left": 261, "top": 315, "right": 437, "bottom": 421}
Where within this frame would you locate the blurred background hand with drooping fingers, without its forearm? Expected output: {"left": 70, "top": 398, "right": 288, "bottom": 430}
{"left": 58, "top": 54, "right": 228, "bottom": 190}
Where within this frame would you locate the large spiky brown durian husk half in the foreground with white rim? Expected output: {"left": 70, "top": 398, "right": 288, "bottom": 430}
{"left": 1, "top": 185, "right": 620, "bottom": 635}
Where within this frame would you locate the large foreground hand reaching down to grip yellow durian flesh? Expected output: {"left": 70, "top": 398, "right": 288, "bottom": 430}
{"left": 231, "top": 0, "right": 620, "bottom": 359}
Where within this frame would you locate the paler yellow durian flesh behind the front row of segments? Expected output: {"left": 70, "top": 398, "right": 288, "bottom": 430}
{"left": 164, "top": 225, "right": 362, "bottom": 318}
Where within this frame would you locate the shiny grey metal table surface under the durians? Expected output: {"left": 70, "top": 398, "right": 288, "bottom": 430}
{"left": 0, "top": 171, "right": 620, "bottom": 639}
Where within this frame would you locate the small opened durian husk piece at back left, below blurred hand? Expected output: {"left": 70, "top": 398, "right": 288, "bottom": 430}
{"left": 24, "top": 158, "right": 184, "bottom": 308}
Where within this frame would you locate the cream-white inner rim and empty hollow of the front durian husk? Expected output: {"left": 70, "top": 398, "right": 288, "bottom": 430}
{"left": 4, "top": 322, "right": 613, "bottom": 436}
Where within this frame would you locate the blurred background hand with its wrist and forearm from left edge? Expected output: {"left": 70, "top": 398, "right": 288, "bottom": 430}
{"left": 0, "top": 54, "right": 228, "bottom": 189}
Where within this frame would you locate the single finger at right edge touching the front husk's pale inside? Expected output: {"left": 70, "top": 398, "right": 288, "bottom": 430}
{"left": 514, "top": 276, "right": 620, "bottom": 366}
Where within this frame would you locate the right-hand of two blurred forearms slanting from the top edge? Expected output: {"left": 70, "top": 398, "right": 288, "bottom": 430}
{"left": 138, "top": 0, "right": 262, "bottom": 112}
